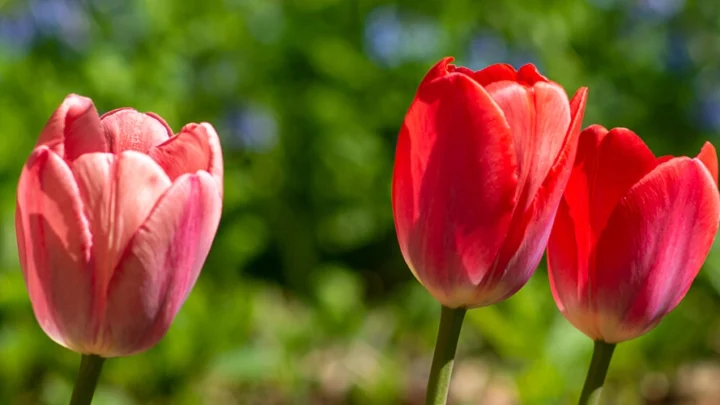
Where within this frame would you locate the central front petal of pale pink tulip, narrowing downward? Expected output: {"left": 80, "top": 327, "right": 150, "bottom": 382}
{"left": 72, "top": 151, "right": 172, "bottom": 344}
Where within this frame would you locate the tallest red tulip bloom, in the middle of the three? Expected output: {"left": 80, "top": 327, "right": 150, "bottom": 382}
{"left": 392, "top": 58, "right": 587, "bottom": 308}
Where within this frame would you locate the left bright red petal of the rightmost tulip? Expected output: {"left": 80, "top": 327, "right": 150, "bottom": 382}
{"left": 548, "top": 125, "right": 655, "bottom": 338}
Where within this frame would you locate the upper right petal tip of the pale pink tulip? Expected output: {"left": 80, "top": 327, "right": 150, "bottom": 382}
{"left": 149, "top": 123, "right": 223, "bottom": 191}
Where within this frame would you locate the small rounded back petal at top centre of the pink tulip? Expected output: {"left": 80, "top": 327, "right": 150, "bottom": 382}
{"left": 100, "top": 108, "right": 173, "bottom": 154}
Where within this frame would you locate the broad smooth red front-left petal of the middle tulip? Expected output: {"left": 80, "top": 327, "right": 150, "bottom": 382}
{"left": 393, "top": 70, "right": 517, "bottom": 306}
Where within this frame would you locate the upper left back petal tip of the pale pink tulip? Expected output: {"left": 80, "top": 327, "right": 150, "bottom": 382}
{"left": 37, "top": 94, "right": 109, "bottom": 161}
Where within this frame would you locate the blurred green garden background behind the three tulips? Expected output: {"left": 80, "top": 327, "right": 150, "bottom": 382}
{"left": 0, "top": 0, "right": 720, "bottom": 405}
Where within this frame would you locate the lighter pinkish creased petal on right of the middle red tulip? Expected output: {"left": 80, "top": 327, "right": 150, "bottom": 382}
{"left": 486, "top": 77, "right": 571, "bottom": 214}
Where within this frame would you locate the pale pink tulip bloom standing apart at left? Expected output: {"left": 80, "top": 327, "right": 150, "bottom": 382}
{"left": 15, "top": 95, "right": 223, "bottom": 357}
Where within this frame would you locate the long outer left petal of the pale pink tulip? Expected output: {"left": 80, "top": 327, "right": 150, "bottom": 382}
{"left": 15, "top": 146, "right": 92, "bottom": 352}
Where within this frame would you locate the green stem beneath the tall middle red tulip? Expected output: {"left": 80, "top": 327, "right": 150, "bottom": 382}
{"left": 425, "top": 306, "right": 467, "bottom": 405}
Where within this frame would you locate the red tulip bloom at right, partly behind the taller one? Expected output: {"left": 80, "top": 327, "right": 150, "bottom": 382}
{"left": 548, "top": 125, "right": 720, "bottom": 343}
